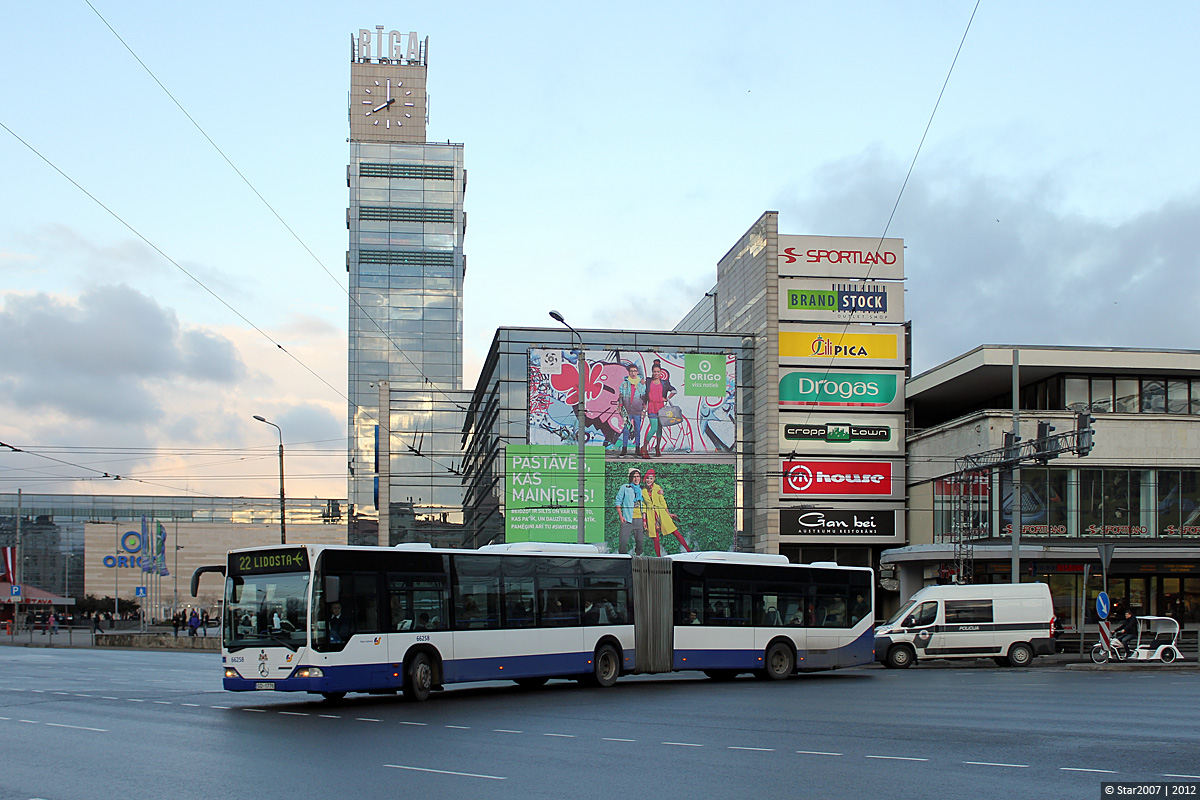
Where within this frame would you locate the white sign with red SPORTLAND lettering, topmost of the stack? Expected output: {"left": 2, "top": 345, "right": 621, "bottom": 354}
{"left": 779, "top": 234, "right": 904, "bottom": 281}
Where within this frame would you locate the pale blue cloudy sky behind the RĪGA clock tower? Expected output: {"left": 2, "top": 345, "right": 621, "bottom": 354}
{"left": 0, "top": 0, "right": 1200, "bottom": 498}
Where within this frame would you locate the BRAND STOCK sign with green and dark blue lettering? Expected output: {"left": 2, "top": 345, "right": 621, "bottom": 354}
{"left": 779, "top": 278, "right": 904, "bottom": 323}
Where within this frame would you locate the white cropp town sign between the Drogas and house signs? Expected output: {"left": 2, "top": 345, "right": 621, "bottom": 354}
{"left": 779, "top": 413, "right": 905, "bottom": 456}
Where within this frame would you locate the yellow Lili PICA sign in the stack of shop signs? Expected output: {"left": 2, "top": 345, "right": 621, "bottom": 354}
{"left": 779, "top": 323, "right": 905, "bottom": 367}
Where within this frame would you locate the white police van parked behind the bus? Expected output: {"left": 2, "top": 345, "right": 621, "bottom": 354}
{"left": 875, "top": 583, "right": 1055, "bottom": 669}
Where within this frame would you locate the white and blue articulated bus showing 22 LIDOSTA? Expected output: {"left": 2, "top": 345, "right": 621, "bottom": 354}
{"left": 192, "top": 543, "right": 875, "bottom": 700}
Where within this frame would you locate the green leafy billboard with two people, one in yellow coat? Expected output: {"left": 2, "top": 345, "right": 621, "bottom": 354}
{"left": 605, "top": 461, "right": 737, "bottom": 555}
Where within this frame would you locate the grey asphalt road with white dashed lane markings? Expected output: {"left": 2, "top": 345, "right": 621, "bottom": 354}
{"left": 0, "top": 646, "right": 1200, "bottom": 800}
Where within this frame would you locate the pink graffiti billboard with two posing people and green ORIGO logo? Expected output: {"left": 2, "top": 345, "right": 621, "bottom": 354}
{"left": 529, "top": 349, "right": 737, "bottom": 458}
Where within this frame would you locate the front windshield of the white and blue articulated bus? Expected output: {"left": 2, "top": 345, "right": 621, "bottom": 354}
{"left": 223, "top": 572, "right": 308, "bottom": 650}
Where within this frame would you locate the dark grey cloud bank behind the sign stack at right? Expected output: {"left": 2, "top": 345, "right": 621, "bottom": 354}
{"left": 778, "top": 152, "right": 1200, "bottom": 372}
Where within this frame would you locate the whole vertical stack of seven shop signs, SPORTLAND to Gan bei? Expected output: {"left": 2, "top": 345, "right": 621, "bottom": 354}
{"left": 779, "top": 235, "right": 908, "bottom": 547}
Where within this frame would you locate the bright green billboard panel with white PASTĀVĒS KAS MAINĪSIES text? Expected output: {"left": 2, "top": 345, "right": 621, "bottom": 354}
{"left": 504, "top": 445, "right": 605, "bottom": 545}
